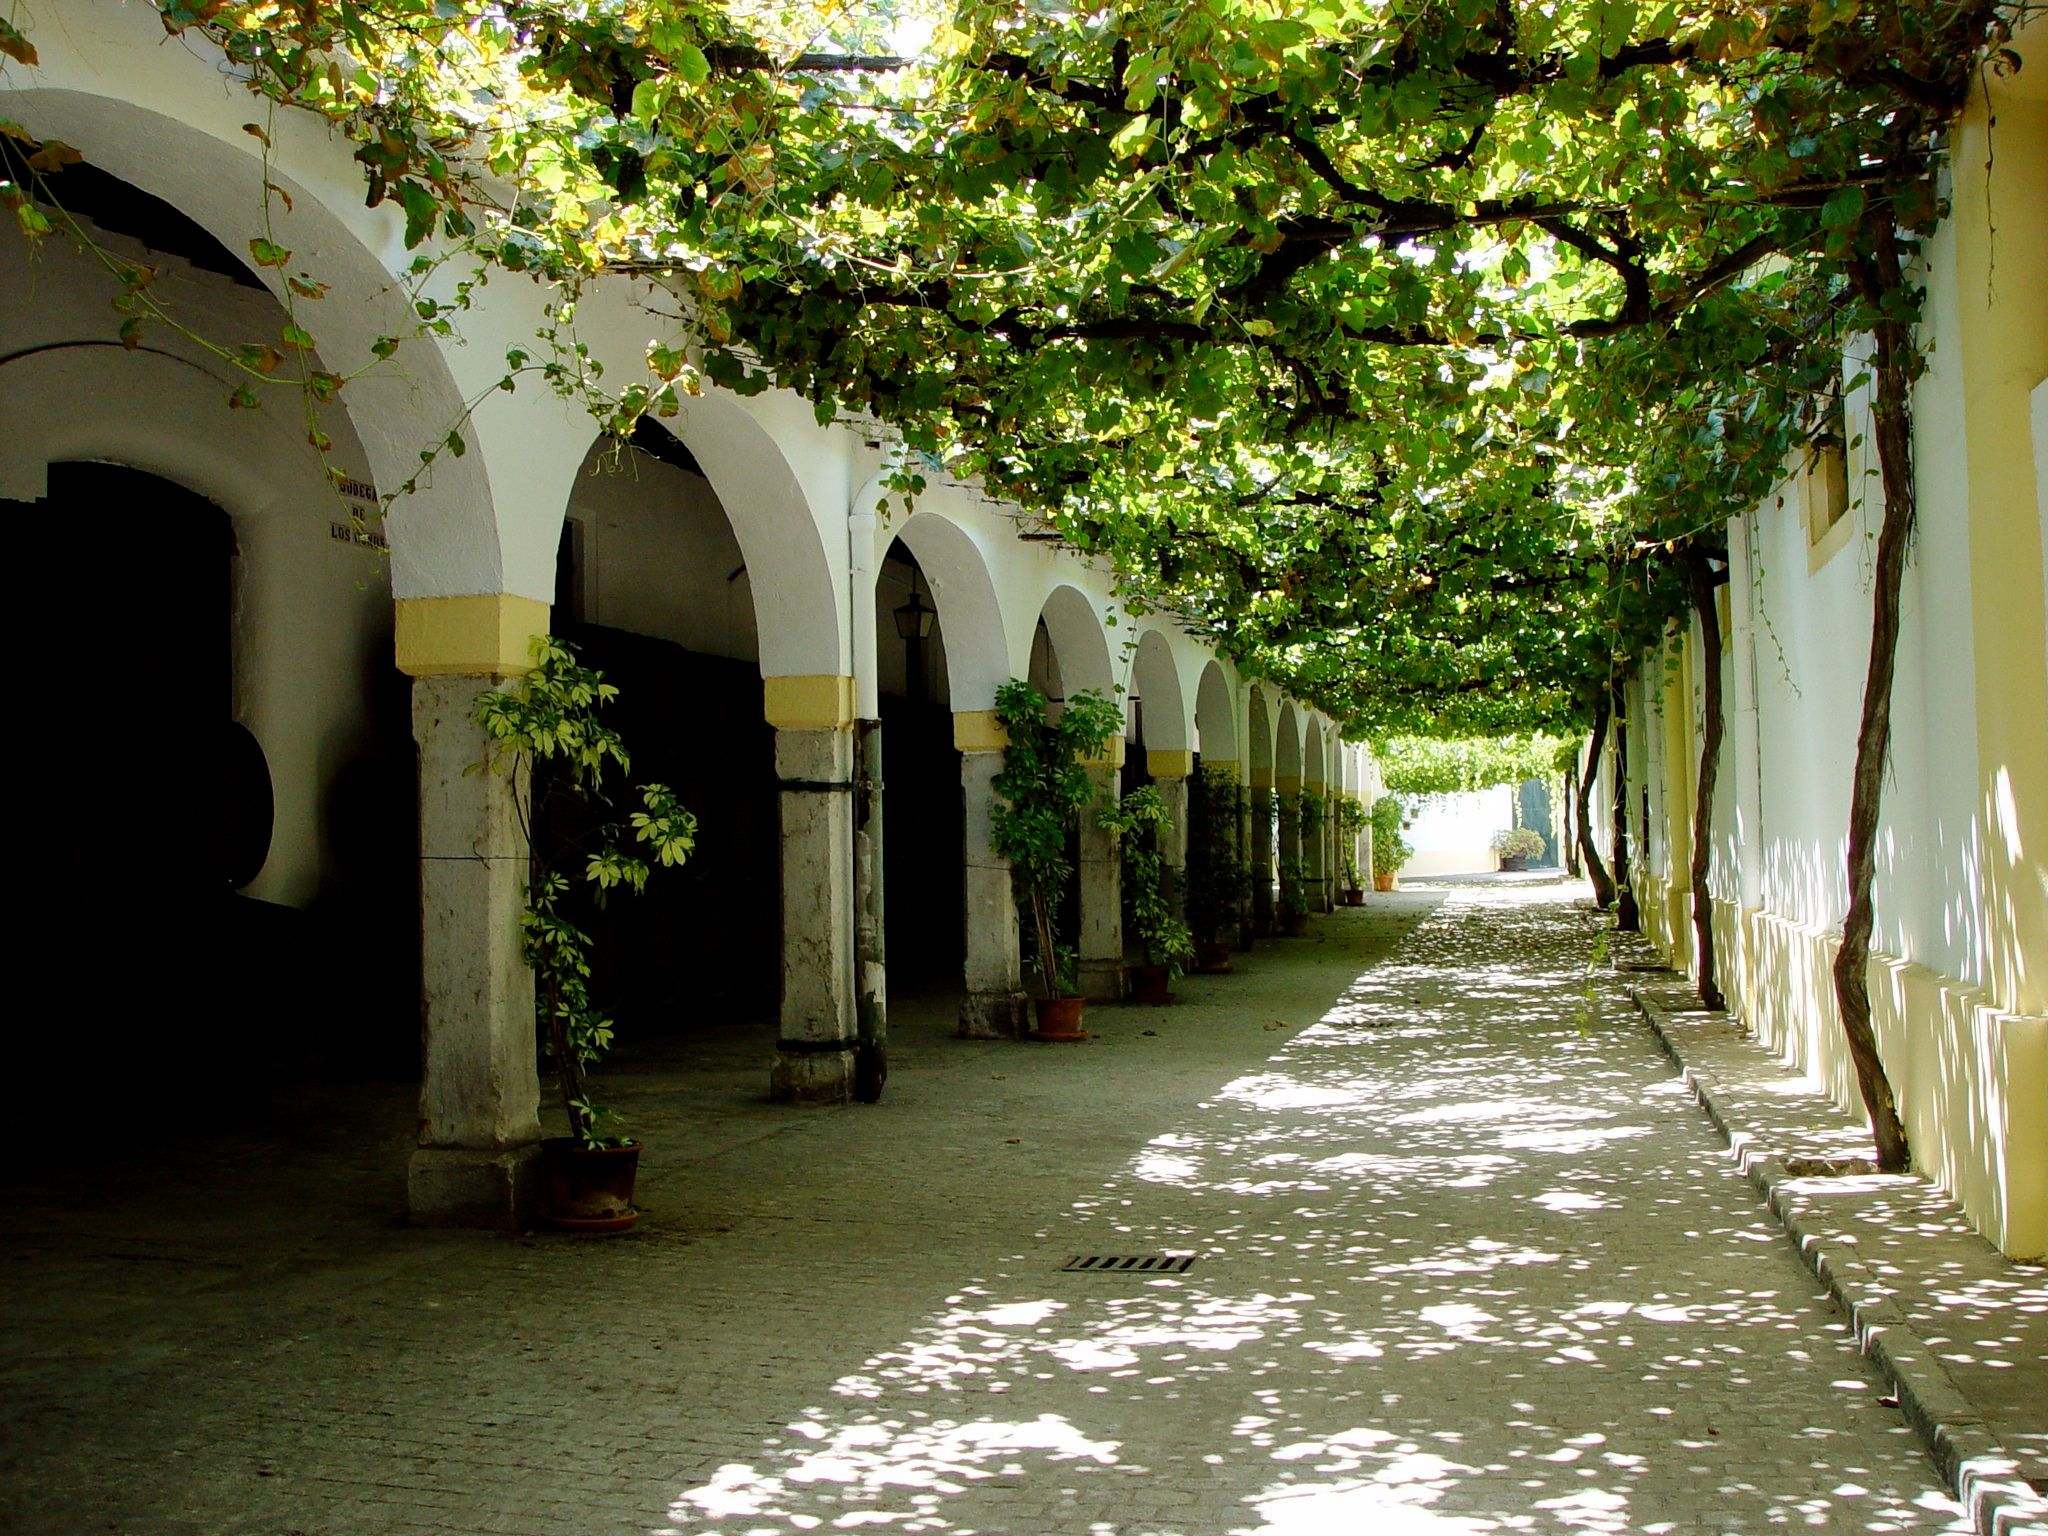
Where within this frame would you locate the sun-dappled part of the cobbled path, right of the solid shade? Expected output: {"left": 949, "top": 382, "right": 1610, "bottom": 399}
{"left": 662, "top": 887, "right": 1968, "bottom": 1536}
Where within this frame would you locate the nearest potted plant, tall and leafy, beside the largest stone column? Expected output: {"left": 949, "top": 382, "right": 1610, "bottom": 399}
{"left": 475, "top": 635, "right": 696, "bottom": 1231}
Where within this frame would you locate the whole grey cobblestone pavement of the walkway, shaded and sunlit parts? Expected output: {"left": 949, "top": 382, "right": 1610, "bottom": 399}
{"left": 0, "top": 885, "right": 1960, "bottom": 1536}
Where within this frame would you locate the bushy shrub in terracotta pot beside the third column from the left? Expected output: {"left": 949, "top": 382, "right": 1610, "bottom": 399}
{"left": 989, "top": 678, "right": 1124, "bottom": 1040}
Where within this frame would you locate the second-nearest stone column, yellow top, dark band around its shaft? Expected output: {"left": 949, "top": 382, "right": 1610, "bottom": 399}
{"left": 762, "top": 674, "right": 858, "bottom": 1104}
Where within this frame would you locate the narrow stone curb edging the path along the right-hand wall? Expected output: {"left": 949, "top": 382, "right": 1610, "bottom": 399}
{"left": 1628, "top": 987, "right": 2048, "bottom": 1536}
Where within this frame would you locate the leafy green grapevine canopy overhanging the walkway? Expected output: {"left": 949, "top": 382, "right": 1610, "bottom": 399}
{"left": 0, "top": 0, "right": 2017, "bottom": 735}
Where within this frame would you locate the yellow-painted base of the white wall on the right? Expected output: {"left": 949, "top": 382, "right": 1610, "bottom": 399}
{"left": 1638, "top": 877, "right": 2048, "bottom": 1260}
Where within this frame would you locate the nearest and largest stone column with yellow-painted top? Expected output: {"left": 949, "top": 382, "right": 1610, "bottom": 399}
{"left": 397, "top": 594, "right": 547, "bottom": 1229}
